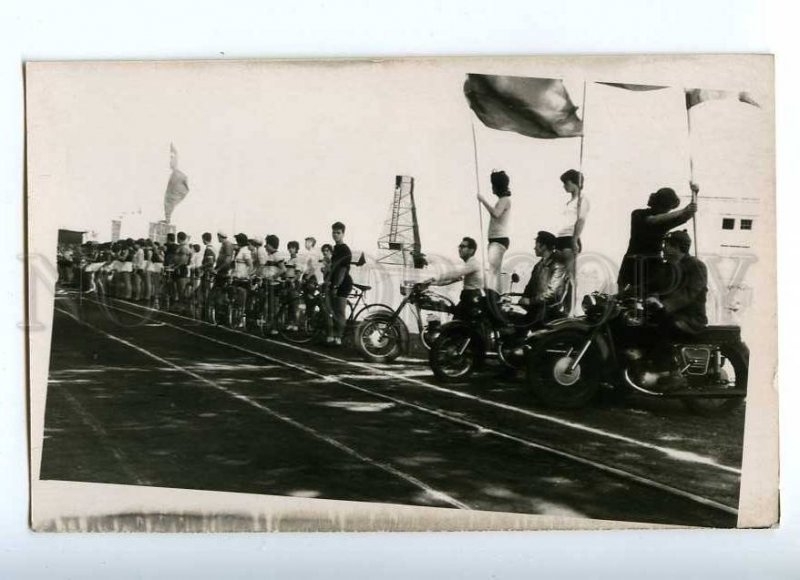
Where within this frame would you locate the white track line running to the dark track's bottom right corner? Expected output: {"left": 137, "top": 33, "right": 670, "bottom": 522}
{"left": 78, "top": 306, "right": 739, "bottom": 515}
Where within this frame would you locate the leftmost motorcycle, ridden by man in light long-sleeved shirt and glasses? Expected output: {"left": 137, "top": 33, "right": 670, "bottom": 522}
{"left": 354, "top": 281, "right": 455, "bottom": 363}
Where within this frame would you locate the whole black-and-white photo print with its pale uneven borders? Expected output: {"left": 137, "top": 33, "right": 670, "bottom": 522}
{"left": 26, "top": 56, "right": 778, "bottom": 531}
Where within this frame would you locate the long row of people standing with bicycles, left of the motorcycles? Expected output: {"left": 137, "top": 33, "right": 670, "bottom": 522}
{"left": 58, "top": 222, "right": 360, "bottom": 345}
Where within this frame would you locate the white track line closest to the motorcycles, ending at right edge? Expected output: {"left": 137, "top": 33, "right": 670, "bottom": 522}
{"left": 100, "top": 301, "right": 742, "bottom": 476}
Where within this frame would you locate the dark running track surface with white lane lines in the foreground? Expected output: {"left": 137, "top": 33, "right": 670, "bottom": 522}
{"left": 41, "top": 297, "right": 744, "bottom": 527}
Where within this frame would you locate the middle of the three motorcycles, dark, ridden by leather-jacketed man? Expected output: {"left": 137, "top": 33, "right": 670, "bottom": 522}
{"left": 428, "top": 274, "right": 552, "bottom": 382}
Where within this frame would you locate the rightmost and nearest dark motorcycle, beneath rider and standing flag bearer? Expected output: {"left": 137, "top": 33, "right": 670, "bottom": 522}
{"left": 526, "top": 292, "right": 749, "bottom": 415}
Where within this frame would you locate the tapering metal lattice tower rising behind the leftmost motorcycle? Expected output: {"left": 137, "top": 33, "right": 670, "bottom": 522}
{"left": 378, "top": 175, "right": 426, "bottom": 268}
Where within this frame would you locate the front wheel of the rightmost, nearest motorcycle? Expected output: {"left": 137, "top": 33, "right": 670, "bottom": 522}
{"left": 526, "top": 331, "right": 600, "bottom": 409}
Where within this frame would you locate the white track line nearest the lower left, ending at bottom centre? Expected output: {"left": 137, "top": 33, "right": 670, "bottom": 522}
{"left": 56, "top": 308, "right": 472, "bottom": 510}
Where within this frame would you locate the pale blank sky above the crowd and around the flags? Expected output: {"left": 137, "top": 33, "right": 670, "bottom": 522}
{"left": 33, "top": 61, "right": 772, "bottom": 330}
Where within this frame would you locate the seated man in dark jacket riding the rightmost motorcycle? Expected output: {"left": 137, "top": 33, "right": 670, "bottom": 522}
{"left": 644, "top": 230, "right": 708, "bottom": 390}
